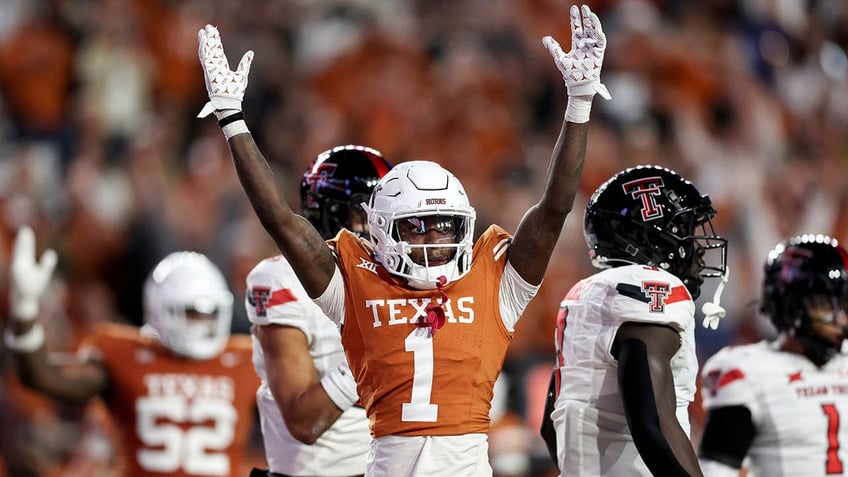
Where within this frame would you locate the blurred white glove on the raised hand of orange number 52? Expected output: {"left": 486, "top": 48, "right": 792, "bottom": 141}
{"left": 9, "top": 226, "right": 57, "bottom": 321}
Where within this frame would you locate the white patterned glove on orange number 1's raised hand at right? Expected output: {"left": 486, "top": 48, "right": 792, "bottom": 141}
{"left": 542, "top": 5, "right": 611, "bottom": 101}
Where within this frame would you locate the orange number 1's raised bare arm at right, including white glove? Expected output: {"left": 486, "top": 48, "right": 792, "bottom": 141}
{"left": 509, "top": 5, "right": 610, "bottom": 284}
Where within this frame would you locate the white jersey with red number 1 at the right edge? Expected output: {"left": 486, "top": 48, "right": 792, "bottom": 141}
{"left": 702, "top": 341, "right": 848, "bottom": 477}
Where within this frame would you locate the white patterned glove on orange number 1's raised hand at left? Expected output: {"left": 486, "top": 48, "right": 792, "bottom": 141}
{"left": 197, "top": 25, "right": 253, "bottom": 119}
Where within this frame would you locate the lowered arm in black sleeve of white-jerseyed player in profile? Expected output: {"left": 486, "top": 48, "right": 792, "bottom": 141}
{"left": 612, "top": 323, "right": 702, "bottom": 477}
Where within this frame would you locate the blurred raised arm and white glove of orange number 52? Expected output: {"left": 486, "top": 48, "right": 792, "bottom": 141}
{"left": 4, "top": 227, "right": 108, "bottom": 405}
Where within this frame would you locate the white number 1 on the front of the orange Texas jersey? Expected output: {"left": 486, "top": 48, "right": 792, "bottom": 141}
{"left": 401, "top": 328, "right": 439, "bottom": 422}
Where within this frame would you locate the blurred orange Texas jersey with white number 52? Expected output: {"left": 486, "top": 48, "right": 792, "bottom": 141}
{"left": 83, "top": 323, "right": 259, "bottom": 477}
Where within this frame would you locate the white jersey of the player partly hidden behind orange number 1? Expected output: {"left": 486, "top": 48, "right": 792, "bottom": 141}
{"left": 245, "top": 256, "right": 371, "bottom": 476}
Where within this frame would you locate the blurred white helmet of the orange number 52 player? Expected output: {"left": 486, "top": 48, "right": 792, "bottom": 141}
{"left": 144, "top": 252, "right": 233, "bottom": 360}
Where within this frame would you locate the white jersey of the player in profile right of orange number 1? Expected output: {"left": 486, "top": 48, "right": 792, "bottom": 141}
{"left": 551, "top": 265, "right": 698, "bottom": 477}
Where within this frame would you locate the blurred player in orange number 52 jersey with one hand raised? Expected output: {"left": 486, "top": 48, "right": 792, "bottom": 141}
{"left": 4, "top": 227, "right": 259, "bottom": 477}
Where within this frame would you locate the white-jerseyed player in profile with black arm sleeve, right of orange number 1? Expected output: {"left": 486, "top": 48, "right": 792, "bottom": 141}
{"left": 542, "top": 166, "right": 726, "bottom": 477}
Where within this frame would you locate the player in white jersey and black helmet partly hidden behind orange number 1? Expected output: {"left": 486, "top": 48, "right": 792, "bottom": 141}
{"left": 245, "top": 145, "right": 391, "bottom": 476}
